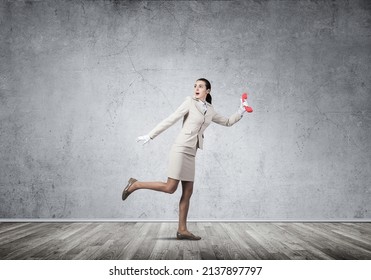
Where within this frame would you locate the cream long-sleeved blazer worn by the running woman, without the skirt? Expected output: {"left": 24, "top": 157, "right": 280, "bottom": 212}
{"left": 148, "top": 96, "right": 242, "bottom": 153}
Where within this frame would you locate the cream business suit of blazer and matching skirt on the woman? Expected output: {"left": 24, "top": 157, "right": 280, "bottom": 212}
{"left": 148, "top": 96, "right": 242, "bottom": 181}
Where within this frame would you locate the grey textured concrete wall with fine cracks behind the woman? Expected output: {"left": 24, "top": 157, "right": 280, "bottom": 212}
{"left": 0, "top": 0, "right": 371, "bottom": 219}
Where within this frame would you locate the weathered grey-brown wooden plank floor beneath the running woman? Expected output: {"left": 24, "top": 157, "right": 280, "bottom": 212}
{"left": 0, "top": 222, "right": 371, "bottom": 260}
